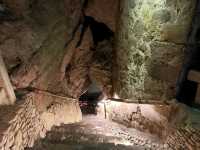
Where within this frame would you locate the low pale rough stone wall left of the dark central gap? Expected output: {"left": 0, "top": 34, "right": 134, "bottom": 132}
{"left": 0, "top": 92, "right": 82, "bottom": 150}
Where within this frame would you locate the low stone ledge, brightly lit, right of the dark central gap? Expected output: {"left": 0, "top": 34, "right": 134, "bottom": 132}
{"left": 97, "top": 99, "right": 200, "bottom": 142}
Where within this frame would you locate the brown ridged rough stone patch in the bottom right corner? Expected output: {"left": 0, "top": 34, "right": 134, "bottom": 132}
{"left": 165, "top": 105, "right": 200, "bottom": 150}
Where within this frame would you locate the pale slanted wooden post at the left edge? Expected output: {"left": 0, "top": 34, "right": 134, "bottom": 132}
{"left": 0, "top": 53, "right": 16, "bottom": 105}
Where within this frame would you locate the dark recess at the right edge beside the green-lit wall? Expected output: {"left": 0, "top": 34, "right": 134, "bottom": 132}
{"left": 176, "top": 8, "right": 200, "bottom": 108}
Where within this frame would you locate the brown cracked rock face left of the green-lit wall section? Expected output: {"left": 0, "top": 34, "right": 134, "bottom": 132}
{"left": 0, "top": 0, "right": 118, "bottom": 98}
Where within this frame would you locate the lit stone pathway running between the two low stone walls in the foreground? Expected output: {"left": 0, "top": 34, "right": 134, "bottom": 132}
{"left": 27, "top": 115, "right": 168, "bottom": 150}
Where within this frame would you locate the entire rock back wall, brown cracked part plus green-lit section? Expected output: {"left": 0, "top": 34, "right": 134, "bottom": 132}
{"left": 0, "top": 0, "right": 196, "bottom": 100}
